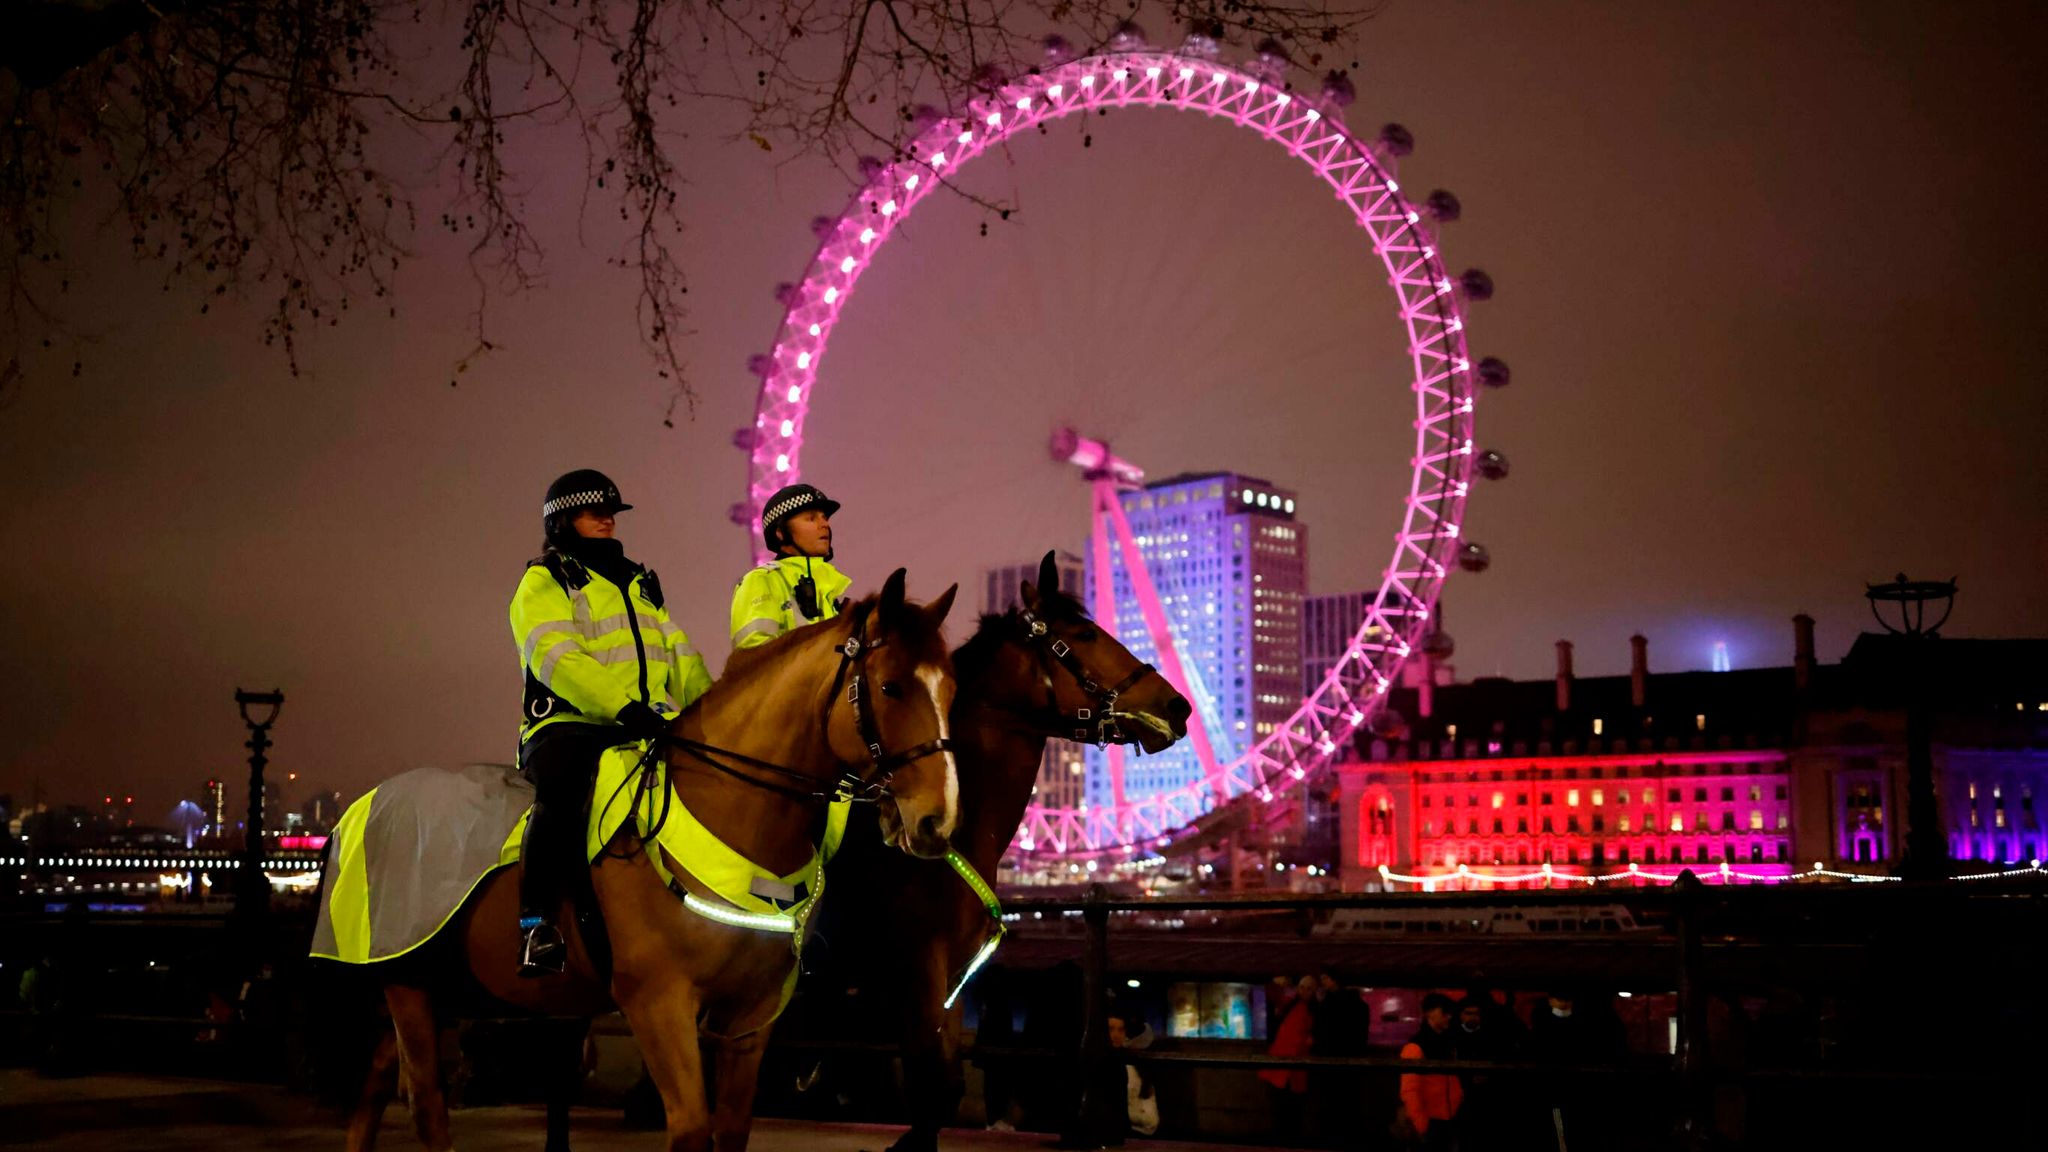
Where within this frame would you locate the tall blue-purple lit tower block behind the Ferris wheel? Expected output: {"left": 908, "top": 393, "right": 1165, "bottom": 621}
{"left": 1087, "top": 471, "right": 1309, "bottom": 806}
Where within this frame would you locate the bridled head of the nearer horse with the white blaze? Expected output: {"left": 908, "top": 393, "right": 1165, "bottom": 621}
{"left": 829, "top": 568, "right": 961, "bottom": 857}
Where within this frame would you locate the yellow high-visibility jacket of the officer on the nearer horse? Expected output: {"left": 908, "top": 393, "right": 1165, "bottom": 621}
{"left": 512, "top": 553, "right": 711, "bottom": 740}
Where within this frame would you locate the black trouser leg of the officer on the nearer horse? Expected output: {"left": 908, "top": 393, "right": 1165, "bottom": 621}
{"left": 518, "top": 722, "right": 625, "bottom": 920}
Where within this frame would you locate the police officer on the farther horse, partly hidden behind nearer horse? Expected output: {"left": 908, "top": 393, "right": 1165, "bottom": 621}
{"left": 733, "top": 484, "right": 852, "bottom": 652}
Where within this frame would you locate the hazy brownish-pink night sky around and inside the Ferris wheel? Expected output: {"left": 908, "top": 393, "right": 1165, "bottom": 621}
{"left": 0, "top": 0, "right": 2048, "bottom": 820}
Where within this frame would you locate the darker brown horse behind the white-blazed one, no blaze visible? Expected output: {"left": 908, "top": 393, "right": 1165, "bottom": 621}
{"left": 802, "top": 553, "right": 1190, "bottom": 1152}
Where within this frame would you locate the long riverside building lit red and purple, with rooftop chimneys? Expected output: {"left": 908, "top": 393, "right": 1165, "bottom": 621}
{"left": 1337, "top": 617, "right": 2048, "bottom": 890}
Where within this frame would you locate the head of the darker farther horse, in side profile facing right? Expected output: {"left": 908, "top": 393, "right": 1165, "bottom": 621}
{"left": 1012, "top": 551, "right": 1192, "bottom": 752}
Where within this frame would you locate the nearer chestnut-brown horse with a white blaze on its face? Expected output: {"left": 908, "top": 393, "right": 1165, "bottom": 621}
{"left": 348, "top": 568, "right": 958, "bottom": 1152}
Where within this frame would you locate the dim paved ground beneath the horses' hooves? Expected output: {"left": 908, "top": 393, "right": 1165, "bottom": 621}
{"left": 0, "top": 1070, "right": 1286, "bottom": 1152}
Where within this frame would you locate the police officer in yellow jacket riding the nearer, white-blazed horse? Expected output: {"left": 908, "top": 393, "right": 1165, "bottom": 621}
{"left": 512, "top": 467, "right": 711, "bottom": 976}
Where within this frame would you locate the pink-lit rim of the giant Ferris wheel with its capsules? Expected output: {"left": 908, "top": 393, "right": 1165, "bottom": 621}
{"left": 731, "top": 39, "right": 1507, "bottom": 857}
